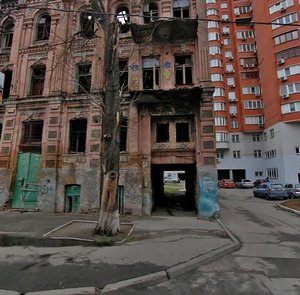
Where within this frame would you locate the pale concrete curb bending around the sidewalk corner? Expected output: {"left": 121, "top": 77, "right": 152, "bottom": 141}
{"left": 101, "top": 219, "right": 241, "bottom": 295}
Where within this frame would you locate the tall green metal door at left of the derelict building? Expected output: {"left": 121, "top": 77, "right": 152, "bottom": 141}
{"left": 12, "top": 153, "right": 41, "bottom": 209}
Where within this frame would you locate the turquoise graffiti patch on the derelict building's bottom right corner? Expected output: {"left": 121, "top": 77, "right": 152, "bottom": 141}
{"left": 198, "top": 175, "right": 220, "bottom": 217}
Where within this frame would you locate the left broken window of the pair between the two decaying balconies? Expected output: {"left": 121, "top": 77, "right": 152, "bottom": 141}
{"left": 143, "top": 57, "right": 160, "bottom": 89}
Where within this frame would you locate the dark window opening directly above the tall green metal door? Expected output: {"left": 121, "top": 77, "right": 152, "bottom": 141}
{"left": 20, "top": 121, "right": 43, "bottom": 152}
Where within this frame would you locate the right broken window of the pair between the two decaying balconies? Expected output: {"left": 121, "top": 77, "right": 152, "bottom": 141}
{"left": 175, "top": 55, "right": 193, "bottom": 85}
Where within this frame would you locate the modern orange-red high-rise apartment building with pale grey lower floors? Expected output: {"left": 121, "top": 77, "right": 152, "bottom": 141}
{"left": 206, "top": 0, "right": 300, "bottom": 183}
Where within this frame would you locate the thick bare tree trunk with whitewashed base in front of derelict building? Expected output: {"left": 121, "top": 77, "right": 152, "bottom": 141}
{"left": 94, "top": 22, "right": 121, "bottom": 235}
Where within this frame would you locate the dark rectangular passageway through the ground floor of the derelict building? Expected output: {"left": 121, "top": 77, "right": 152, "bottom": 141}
{"left": 151, "top": 164, "right": 196, "bottom": 216}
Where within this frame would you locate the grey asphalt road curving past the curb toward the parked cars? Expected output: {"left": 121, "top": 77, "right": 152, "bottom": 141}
{"left": 113, "top": 189, "right": 300, "bottom": 295}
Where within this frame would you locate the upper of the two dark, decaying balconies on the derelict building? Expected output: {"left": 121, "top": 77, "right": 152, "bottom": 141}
{"left": 130, "top": 18, "right": 198, "bottom": 44}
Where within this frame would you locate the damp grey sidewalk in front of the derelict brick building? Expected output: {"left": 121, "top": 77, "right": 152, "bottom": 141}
{"left": 0, "top": 212, "right": 239, "bottom": 295}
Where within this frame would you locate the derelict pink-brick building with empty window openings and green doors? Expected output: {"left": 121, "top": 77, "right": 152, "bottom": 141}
{"left": 0, "top": 0, "right": 216, "bottom": 214}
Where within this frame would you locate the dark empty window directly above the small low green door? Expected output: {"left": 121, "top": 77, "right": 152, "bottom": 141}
{"left": 69, "top": 119, "right": 87, "bottom": 153}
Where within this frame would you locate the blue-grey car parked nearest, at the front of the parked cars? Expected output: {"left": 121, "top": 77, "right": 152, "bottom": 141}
{"left": 253, "top": 182, "right": 288, "bottom": 200}
